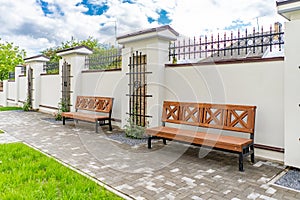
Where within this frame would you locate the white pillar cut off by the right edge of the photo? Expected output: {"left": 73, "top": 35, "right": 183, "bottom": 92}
{"left": 277, "top": 1, "right": 300, "bottom": 168}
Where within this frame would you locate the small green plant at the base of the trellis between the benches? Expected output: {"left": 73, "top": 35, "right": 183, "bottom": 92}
{"left": 124, "top": 116, "right": 146, "bottom": 139}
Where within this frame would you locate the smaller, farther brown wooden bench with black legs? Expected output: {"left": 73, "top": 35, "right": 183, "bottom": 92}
{"left": 62, "top": 96, "right": 113, "bottom": 133}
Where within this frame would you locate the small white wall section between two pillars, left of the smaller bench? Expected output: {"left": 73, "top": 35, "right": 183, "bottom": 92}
{"left": 40, "top": 75, "right": 61, "bottom": 108}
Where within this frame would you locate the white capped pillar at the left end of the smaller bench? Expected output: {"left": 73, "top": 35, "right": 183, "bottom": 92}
{"left": 57, "top": 46, "right": 93, "bottom": 111}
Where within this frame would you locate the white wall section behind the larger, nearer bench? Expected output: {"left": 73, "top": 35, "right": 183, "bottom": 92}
{"left": 165, "top": 61, "right": 284, "bottom": 148}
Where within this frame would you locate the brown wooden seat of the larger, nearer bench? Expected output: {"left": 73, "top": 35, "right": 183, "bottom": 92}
{"left": 147, "top": 126, "right": 253, "bottom": 152}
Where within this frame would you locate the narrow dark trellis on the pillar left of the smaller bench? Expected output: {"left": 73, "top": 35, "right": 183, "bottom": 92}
{"left": 61, "top": 61, "right": 71, "bottom": 111}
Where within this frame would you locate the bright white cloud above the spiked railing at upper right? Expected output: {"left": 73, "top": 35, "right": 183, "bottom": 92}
{"left": 171, "top": 0, "right": 283, "bottom": 36}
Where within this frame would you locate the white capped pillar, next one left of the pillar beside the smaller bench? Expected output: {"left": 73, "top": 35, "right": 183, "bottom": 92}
{"left": 24, "top": 55, "right": 49, "bottom": 109}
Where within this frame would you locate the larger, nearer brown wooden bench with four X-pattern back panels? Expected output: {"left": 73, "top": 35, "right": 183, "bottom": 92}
{"left": 146, "top": 101, "right": 256, "bottom": 171}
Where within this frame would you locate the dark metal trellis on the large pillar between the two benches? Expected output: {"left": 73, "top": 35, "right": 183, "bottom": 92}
{"left": 127, "top": 52, "right": 152, "bottom": 126}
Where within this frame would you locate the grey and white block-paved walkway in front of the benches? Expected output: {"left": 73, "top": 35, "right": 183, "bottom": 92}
{"left": 0, "top": 112, "right": 300, "bottom": 200}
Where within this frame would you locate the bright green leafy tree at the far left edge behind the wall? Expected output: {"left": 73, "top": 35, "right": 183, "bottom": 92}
{"left": 0, "top": 38, "right": 26, "bottom": 81}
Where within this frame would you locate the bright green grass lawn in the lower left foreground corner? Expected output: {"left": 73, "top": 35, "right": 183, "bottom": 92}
{"left": 0, "top": 143, "right": 121, "bottom": 200}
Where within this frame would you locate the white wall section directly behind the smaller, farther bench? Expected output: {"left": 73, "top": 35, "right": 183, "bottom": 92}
{"left": 80, "top": 71, "right": 123, "bottom": 120}
